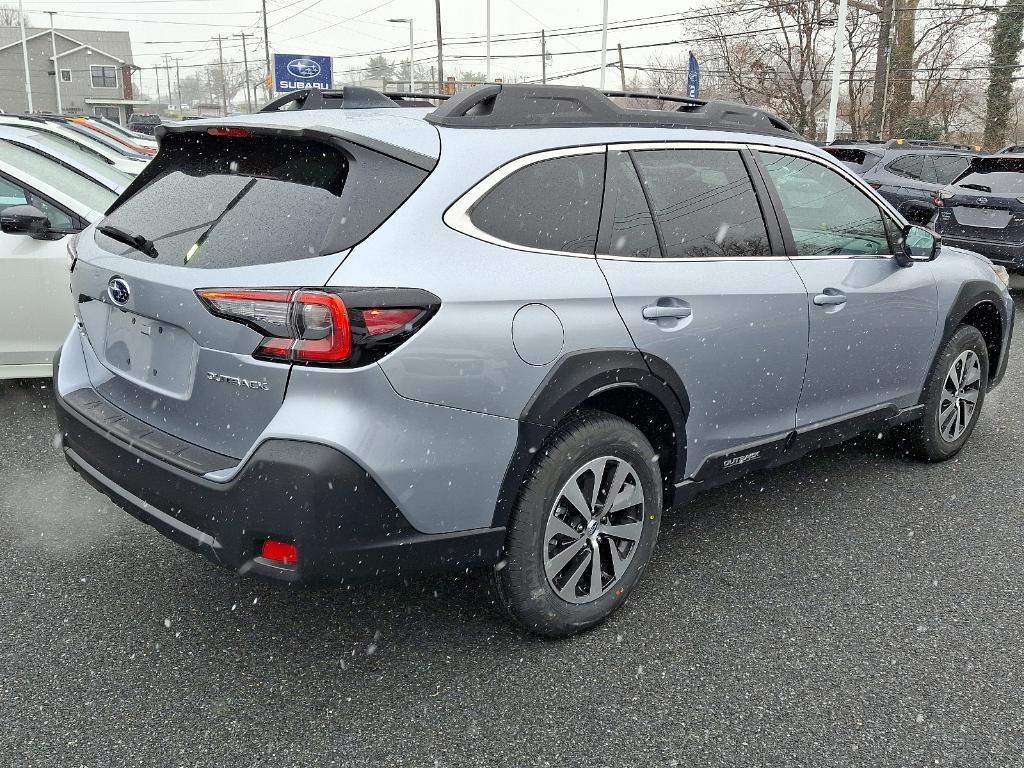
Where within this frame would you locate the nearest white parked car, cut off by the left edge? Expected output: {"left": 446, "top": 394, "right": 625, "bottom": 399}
{"left": 0, "top": 141, "right": 116, "bottom": 379}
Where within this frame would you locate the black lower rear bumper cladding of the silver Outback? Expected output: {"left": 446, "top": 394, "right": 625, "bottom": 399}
{"left": 56, "top": 385, "right": 505, "bottom": 583}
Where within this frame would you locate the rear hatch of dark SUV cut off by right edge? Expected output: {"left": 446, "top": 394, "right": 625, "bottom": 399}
{"left": 936, "top": 157, "right": 1024, "bottom": 243}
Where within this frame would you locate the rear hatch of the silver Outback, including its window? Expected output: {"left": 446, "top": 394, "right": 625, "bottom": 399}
{"left": 72, "top": 124, "right": 433, "bottom": 459}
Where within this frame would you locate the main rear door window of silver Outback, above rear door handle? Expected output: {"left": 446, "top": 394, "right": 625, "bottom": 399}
{"left": 633, "top": 150, "right": 770, "bottom": 259}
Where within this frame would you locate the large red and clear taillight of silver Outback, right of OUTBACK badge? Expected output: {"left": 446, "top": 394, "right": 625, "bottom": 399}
{"left": 196, "top": 288, "right": 440, "bottom": 367}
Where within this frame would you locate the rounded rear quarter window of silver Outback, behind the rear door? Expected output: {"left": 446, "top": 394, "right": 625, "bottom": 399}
{"left": 469, "top": 153, "right": 604, "bottom": 254}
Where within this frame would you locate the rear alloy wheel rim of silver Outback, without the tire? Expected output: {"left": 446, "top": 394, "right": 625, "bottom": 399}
{"left": 544, "top": 456, "right": 644, "bottom": 604}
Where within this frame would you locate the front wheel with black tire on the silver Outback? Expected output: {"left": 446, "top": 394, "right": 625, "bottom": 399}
{"left": 908, "top": 326, "right": 988, "bottom": 462}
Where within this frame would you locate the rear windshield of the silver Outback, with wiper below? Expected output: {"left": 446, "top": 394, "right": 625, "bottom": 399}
{"left": 96, "top": 133, "right": 426, "bottom": 268}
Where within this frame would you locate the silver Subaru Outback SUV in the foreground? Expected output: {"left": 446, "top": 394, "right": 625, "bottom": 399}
{"left": 54, "top": 85, "right": 1014, "bottom": 636}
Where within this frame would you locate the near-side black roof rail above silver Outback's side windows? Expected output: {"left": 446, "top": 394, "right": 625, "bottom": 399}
{"left": 426, "top": 84, "right": 800, "bottom": 138}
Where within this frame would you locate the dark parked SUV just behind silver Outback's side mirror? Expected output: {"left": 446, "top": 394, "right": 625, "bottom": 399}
{"left": 824, "top": 138, "right": 980, "bottom": 213}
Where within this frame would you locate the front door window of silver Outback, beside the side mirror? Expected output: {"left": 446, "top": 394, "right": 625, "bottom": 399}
{"left": 761, "top": 153, "right": 891, "bottom": 256}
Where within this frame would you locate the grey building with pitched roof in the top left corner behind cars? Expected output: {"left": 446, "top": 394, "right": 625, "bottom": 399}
{"left": 0, "top": 27, "right": 152, "bottom": 124}
